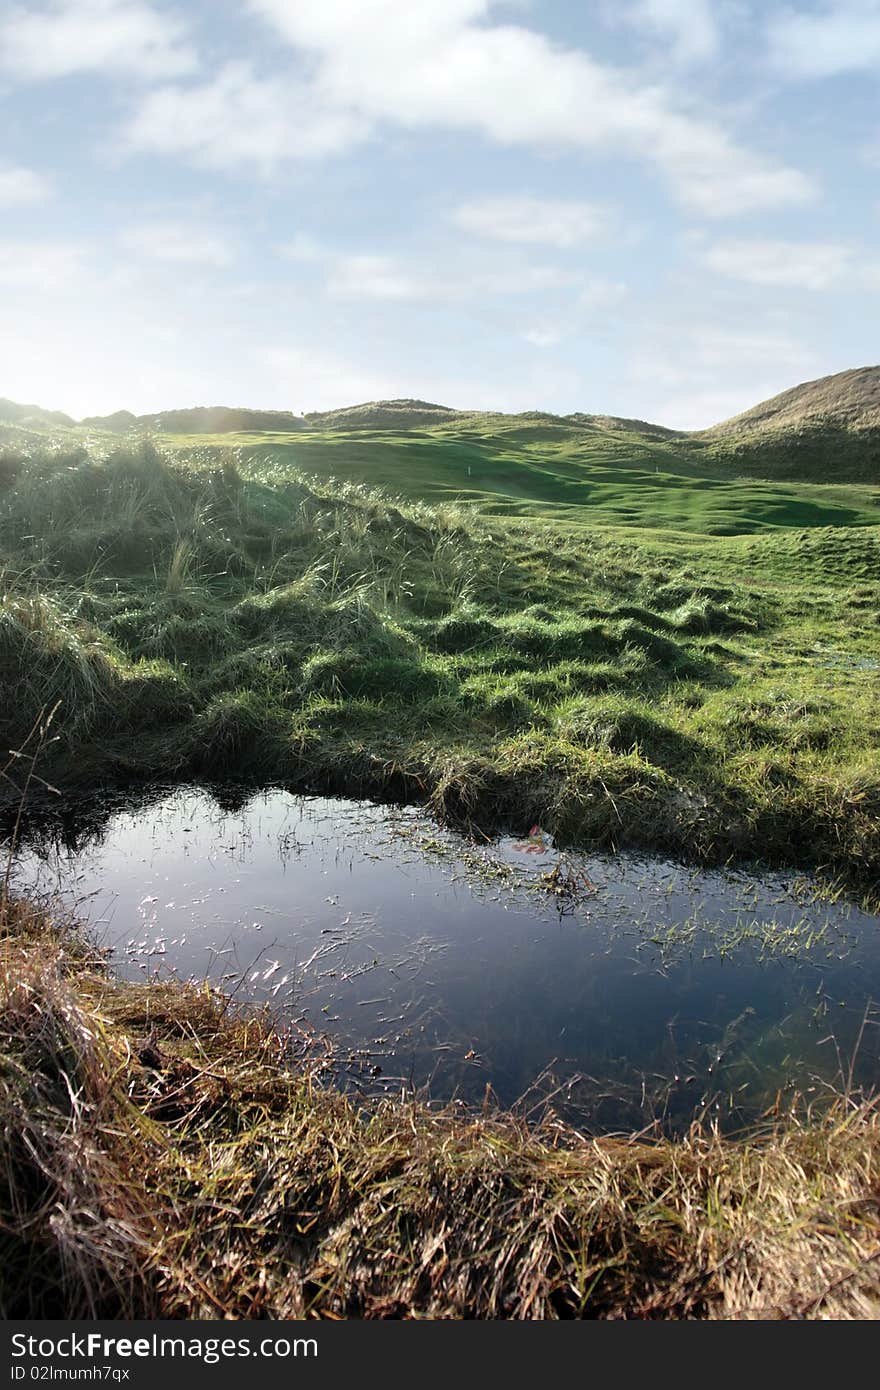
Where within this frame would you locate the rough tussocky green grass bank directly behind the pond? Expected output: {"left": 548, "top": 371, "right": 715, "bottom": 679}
{"left": 0, "top": 445, "right": 880, "bottom": 895}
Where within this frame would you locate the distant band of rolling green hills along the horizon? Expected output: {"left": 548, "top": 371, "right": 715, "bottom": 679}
{"left": 0, "top": 367, "right": 880, "bottom": 535}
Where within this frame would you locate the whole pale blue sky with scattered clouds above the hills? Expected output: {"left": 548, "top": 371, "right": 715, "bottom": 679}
{"left": 0, "top": 0, "right": 880, "bottom": 430}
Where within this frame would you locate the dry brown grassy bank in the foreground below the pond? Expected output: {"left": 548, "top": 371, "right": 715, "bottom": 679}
{"left": 0, "top": 904, "right": 880, "bottom": 1319}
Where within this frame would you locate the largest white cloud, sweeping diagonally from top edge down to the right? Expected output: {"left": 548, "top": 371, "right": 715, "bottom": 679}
{"left": 139, "top": 0, "right": 815, "bottom": 217}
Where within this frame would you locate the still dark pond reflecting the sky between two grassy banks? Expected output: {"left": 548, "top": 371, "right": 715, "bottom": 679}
{"left": 8, "top": 788, "right": 880, "bottom": 1131}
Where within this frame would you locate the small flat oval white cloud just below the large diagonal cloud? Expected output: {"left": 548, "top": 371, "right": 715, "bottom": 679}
{"left": 452, "top": 197, "right": 608, "bottom": 250}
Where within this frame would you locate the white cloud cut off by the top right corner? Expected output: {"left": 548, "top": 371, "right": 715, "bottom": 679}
{"left": 767, "top": 0, "right": 880, "bottom": 79}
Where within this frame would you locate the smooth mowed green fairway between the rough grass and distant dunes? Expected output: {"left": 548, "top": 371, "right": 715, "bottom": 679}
{"left": 152, "top": 417, "right": 880, "bottom": 535}
